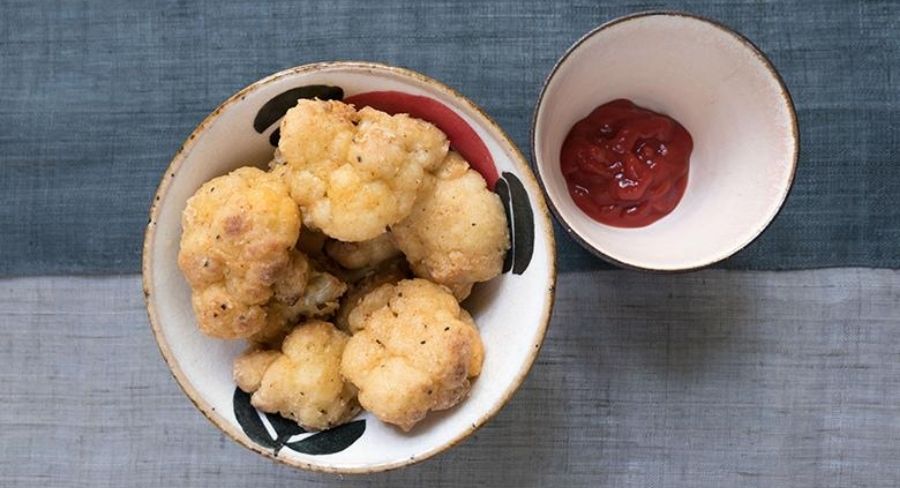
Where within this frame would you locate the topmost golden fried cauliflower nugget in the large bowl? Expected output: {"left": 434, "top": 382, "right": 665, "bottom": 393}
{"left": 272, "top": 100, "right": 449, "bottom": 242}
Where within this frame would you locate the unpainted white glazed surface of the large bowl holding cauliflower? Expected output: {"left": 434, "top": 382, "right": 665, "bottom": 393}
{"left": 145, "top": 64, "right": 554, "bottom": 472}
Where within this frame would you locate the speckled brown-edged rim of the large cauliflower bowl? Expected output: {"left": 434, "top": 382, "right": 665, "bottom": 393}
{"left": 141, "top": 61, "right": 557, "bottom": 474}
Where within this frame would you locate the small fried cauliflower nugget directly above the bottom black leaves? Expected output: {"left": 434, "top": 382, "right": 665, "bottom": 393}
{"left": 250, "top": 321, "right": 359, "bottom": 430}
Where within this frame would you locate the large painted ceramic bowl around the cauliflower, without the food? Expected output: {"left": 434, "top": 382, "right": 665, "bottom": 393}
{"left": 143, "top": 62, "right": 556, "bottom": 473}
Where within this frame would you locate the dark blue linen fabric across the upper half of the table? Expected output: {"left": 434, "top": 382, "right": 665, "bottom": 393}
{"left": 0, "top": 0, "right": 900, "bottom": 276}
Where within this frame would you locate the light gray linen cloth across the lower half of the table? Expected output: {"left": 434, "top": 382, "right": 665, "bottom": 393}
{"left": 0, "top": 269, "right": 900, "bottom": 488}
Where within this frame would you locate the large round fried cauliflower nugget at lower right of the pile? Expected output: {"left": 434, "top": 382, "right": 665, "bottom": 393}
{"left": 341, "top": 279, "right": 484, "bottom": 431}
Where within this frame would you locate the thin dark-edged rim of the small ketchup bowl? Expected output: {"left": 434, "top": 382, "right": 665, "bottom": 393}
{"left": 531, "top": 10, "right": 800, "bottom": 274}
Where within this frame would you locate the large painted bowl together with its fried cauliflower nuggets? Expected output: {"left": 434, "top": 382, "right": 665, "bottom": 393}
{"left": 143, "top": 62, "right": 556, "bottom": 473}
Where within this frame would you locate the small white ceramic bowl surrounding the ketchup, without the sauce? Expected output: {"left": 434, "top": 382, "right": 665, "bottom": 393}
{"left": 532, "top": 12, "right": 799, "bottom": 271}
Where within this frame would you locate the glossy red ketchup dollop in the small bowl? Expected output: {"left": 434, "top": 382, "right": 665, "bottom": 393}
{"left": 560, "top": 99, "right": 694, "bottom": 227}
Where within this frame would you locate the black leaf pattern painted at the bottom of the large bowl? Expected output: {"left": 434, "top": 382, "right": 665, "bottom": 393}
{"left": 233, "top": 388, "right": 366, "bottom": 456}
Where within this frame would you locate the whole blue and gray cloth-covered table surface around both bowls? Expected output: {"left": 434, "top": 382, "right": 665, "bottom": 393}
{"left": 0, "top": 0, "right": 900, "bottom": 488}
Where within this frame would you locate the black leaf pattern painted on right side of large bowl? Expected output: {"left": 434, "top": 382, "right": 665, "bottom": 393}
{"left": 494, "top": 172, "right": 534, "bottom": 275}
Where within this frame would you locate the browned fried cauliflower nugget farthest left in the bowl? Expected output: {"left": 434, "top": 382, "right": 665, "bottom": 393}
{"left": 178, "top": 167, "right": 300, "bottom": 339}
